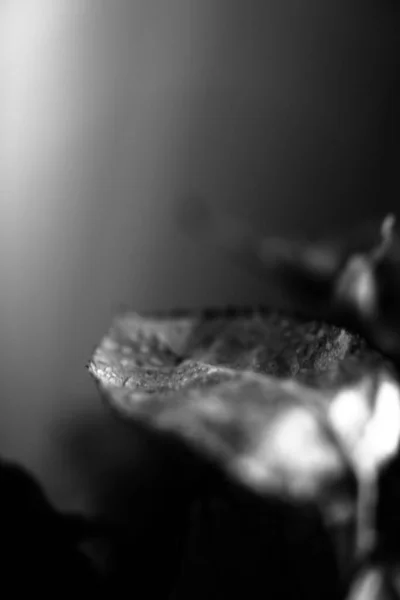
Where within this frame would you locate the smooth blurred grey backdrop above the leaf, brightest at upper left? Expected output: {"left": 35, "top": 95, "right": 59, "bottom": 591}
{"left": 0, "top": 0, "right": 400, "bottom": 510}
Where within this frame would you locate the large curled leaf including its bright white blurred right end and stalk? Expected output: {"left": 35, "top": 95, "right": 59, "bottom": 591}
{"left": 89, "top": 313, "right": 400, "bottom": 546}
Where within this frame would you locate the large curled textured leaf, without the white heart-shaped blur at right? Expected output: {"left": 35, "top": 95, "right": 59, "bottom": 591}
{"left": 89, "top": 311, "right": 388, "bottom": 497}
